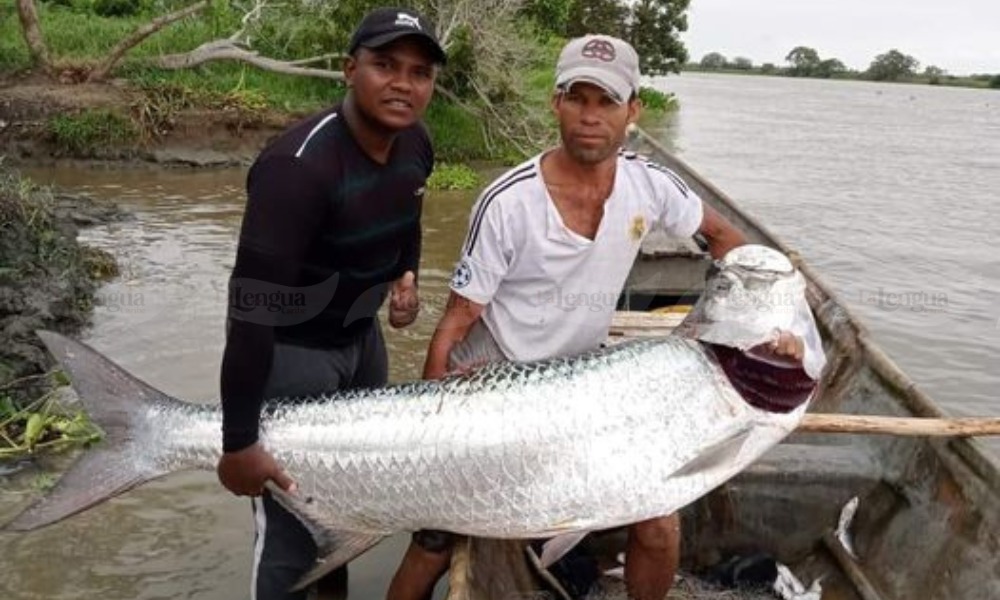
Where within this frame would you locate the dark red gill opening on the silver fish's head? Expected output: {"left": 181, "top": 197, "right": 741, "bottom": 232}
{"left": 703, "top": 342, "right": 816, "bottom": 413}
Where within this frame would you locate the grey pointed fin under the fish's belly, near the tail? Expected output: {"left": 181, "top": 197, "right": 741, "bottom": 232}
{"left": 266, "top": 482, "right": 388, "bottom": 591}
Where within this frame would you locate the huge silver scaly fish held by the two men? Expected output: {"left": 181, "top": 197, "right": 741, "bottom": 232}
{"left": 8, "top": 247, "right": 822, "bottom": 584}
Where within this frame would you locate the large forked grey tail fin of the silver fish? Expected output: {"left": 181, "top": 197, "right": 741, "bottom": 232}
{"left": 5, "top": 331, "right": 181, "bottom": 531}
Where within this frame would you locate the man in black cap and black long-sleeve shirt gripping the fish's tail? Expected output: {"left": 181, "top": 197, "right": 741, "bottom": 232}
{"left": 218, "top": 8, "right": 446, "bottom": 600}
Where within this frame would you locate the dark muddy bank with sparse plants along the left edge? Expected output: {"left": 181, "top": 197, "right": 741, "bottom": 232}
{"left": 0, "top": 162, "right": 115, "bottom": 461}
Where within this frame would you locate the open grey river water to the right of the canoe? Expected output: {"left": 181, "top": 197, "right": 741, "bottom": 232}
{"left": 644, "top": 73, "right": 1000, "bottom": 426}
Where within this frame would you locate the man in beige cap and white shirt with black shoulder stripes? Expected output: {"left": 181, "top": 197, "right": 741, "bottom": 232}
{"left": 390, "top": 35, "right": 745, "bottom": 600}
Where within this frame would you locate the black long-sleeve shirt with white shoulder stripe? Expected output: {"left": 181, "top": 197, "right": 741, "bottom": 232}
{"left": 221, "top": 106, "right": 434, "bottom": 452}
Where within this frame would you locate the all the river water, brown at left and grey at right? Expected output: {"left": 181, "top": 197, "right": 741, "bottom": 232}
{"left": 0, "top": 74, "right": 1000, "bottom": 600}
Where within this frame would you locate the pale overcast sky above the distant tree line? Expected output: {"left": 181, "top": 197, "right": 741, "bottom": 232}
{"left": 681, "top": 0, "right": 1000, "bottom": 75}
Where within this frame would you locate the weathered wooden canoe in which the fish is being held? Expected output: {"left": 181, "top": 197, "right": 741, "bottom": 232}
{"left": 448, "top": 131, "right": 1000, "bottom": 600}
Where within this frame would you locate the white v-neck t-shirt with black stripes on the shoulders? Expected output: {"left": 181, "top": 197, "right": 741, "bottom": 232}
{"left": 451, "top": 153, "right": 702, "bottom": 361}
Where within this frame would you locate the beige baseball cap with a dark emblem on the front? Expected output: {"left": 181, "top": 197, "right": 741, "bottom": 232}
{"left": 556, "top": 35, "right": 641, "bottom": 104}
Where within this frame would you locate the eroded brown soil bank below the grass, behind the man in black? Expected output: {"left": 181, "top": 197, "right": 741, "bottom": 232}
{"left": 0, "top": 75, "right": 303, "bottom": 166}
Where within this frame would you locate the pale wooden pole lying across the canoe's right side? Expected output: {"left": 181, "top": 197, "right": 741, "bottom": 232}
{"left": 796, "top": 413, "right": 1000, "bottom": 437}
